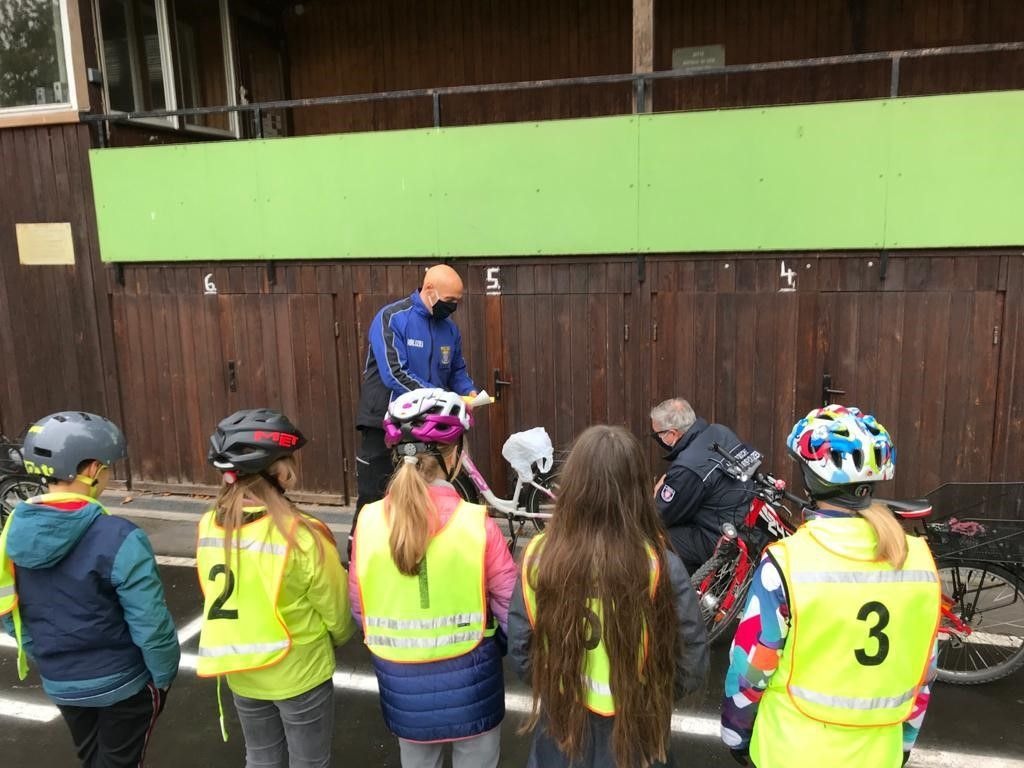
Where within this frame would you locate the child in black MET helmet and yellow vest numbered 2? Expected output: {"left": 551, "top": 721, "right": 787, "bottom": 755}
{"left": 196, "top": 409, "right": 355, "bottom": 768}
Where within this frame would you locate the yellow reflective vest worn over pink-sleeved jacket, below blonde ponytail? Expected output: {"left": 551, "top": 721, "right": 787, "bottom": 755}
{"left": 355, "top": 501, "right": 495, "bottom": 664}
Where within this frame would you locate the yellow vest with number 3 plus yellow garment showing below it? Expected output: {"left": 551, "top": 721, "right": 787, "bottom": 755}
{"left": 752, "top": 517, "right": 941, "bottom": 768}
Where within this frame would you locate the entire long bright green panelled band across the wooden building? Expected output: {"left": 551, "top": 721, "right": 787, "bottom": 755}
{"left": 91, "top": 91, "right": 1024, "bottom": 261}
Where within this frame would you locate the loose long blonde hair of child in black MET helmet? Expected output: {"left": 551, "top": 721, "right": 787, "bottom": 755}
{"left": 215, "top": 456, "right": 327, "bottom": 563}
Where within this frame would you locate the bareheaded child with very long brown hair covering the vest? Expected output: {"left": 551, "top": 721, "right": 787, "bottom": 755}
{"left": 509, "top": 425, "right": 708, "bottom": 768}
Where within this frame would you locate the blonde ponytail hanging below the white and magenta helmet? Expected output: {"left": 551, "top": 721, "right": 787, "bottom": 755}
{"left": 384, "top": 445, "right": 455, "bottom": 575}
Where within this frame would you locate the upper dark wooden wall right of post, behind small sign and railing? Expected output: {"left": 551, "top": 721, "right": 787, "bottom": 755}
{"left": 654, "top": 0, "right": 1024, "bottom": 110}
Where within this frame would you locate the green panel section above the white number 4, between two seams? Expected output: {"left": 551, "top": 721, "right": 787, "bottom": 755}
{"left": 639, "top": 101, "right": 887, "bottom": 252}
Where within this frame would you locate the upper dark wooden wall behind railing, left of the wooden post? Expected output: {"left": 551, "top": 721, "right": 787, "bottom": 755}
{"left": 284, "top": 0, "right": 632, "bottom": 135}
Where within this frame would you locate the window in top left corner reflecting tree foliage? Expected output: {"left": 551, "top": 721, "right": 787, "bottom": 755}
{"left": 0, "top": 0, "right": 75, "bottom": 112}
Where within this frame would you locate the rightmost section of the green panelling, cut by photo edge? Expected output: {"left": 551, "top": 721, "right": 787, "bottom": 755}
{"left": 886, "top": 91, "right": 1024, "bottom": 248}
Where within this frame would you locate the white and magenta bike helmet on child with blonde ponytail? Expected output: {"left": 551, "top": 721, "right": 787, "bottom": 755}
{"left": 384, "top": 389, "right": 473, "bottom": 447}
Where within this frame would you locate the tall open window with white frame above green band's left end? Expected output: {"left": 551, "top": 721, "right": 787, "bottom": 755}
{"left": 94, "top": 0, "right": 237, "bottom": 133}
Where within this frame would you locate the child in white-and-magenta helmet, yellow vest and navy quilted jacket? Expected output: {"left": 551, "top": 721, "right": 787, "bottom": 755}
{"left": 349, "top": 389, "right": 515, "bottom": 768}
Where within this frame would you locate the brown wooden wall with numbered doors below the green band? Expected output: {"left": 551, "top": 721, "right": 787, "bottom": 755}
{"left": 101, "top": 252, "right": 1024, "bottom": 505}
